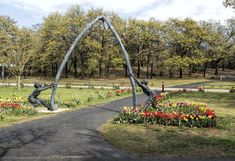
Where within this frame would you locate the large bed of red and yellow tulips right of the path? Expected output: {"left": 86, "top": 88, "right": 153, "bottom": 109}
{"left": 113, "top": 91, "right": 216, "bottom": 127}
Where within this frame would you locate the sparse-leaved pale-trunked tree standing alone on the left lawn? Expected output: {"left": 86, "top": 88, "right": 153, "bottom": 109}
{"left": 0, "top": 23, "right": 36, "bottom": 90}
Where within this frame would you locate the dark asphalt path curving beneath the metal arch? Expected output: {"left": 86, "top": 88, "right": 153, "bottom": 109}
{"left": 0, "top": 95, "right": 232, "bottom": 161}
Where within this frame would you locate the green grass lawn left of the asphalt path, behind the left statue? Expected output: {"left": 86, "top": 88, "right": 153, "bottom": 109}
{"left": 0, "top": 87, "right": 135, "bottom": 126}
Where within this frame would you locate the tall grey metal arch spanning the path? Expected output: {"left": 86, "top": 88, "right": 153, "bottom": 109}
{"left": 50, "top": 16, "right": 137, "bottom": 111}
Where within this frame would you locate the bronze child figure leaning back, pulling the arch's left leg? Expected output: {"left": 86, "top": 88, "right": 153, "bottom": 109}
{"left": 28, "top": 82, "right": 54, "bottom": 110}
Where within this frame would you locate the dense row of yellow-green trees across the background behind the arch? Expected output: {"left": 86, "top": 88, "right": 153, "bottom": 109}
{"left": 0, "top": 6, "right": 235, "bottom": 82}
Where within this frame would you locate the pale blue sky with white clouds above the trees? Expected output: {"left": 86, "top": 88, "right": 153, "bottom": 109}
{"left": 0, "top": 0, "right": 235, "bottom": 26}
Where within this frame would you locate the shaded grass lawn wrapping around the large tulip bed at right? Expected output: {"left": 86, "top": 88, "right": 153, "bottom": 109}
{"left": 100, "top": 92, "right": 235, "bottom": 158}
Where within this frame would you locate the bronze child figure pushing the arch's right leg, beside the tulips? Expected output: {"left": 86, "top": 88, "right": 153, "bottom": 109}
{"left": 131, "top": 75, "right": 157, "bottom": 111}
